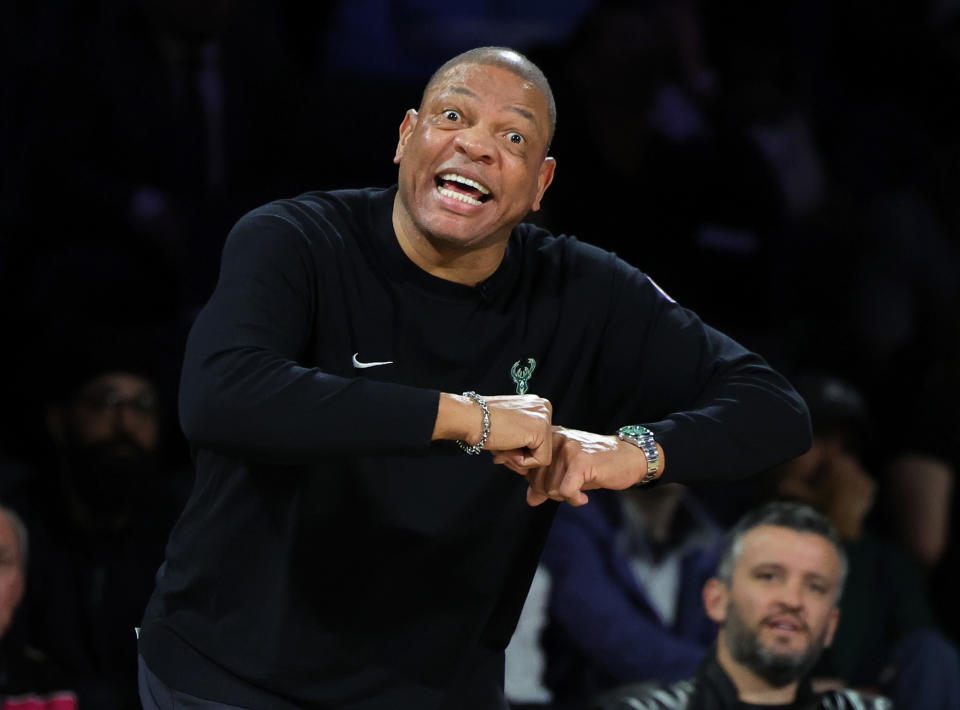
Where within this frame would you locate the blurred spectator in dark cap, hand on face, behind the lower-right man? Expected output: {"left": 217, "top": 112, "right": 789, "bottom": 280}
{"left": 776, "top": 375, "right": 960, "bottom": 708}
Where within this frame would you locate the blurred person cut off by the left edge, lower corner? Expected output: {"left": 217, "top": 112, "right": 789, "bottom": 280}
{"left": 0, "top": 506, "right": 77, "bottom": 710}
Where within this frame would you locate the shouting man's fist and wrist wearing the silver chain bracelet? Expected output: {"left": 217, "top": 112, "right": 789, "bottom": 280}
{"left": 433, "top": 392, "right": 553, "bottom": 468}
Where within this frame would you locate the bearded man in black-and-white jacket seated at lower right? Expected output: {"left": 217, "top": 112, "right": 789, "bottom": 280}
{"left": 594, "top": 502, "right": 892, "bottom": 710}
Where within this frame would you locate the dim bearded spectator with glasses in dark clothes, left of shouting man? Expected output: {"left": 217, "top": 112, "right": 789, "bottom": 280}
{"left": 6, "top": 327, "right": 189, "bottom": 710}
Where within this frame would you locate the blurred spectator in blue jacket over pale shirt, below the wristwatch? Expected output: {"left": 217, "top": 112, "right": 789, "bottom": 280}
{"left": 542, "top": 484, "right": 721, "bottom": 707}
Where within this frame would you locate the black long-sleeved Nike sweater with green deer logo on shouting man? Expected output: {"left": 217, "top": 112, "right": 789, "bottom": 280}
{"left": 141, "top": 188, "right": 809, "bottom": 708}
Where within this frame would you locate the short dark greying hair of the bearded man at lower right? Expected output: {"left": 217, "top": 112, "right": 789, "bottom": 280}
{"left": 716, "top": 501, "right": 847, "bottom": 599}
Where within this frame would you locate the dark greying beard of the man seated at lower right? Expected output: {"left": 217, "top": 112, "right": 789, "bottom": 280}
{"left": 724, "top": 602, "right": 827, "bottom": 688}
